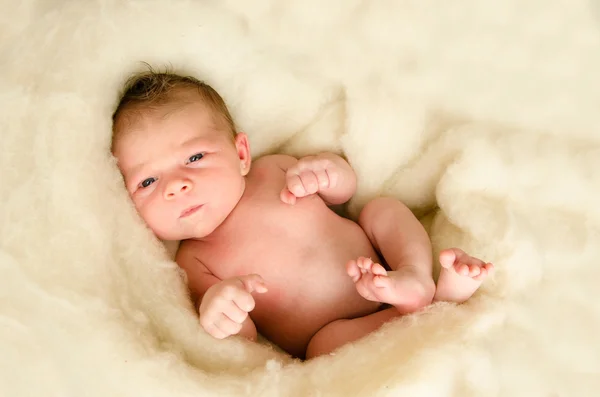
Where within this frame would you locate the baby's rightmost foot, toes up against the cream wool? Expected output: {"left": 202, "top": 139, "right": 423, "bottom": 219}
{"left": 434, "top": 248, "right": 494, "bottom": 303}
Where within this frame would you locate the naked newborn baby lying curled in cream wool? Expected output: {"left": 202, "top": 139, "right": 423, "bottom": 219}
{"left": 112, "top": 71, "right": 493, "bottom": 358}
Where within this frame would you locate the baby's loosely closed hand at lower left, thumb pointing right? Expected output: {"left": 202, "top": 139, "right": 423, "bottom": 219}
{"left": 200, "top": 274, "right": 267, "bottom": 339}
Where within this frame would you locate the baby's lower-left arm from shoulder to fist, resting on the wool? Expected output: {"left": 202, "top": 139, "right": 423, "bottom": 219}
{"left": 176, "top": 242, "right": 264, "bottom": 341}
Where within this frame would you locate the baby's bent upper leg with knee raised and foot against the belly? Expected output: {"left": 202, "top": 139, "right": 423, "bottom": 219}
{"left": 347, "top": 198, "right": 435, "bottom": 313}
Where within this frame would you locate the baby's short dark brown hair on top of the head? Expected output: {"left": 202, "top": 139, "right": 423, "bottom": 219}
{"left": 112, "top": 64, "right": 236, "bottom": 148}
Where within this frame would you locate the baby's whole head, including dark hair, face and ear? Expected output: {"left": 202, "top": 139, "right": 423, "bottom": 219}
{"left": 111, "top": 71, "right": 251, "bottom": 240}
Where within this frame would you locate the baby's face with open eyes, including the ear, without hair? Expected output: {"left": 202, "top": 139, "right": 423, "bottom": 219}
{"left": 114, "top": 102, "right": 250, "bottom": 240}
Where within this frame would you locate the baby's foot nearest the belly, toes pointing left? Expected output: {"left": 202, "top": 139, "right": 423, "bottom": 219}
{"left": 346, "top": 257, "right": 435, "bottom": 313}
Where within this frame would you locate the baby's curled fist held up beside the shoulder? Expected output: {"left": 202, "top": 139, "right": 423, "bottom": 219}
{"left": 280, "top": 156, "right": 340, "bottom": 204}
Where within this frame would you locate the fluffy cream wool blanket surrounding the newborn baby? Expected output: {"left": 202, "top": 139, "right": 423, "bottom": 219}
{"left": 0, "top": 0, "right": 600, "bottom": 397}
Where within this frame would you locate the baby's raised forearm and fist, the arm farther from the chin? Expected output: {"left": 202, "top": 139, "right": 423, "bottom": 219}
{"left": 281, "top": 153, "right": 356, "bottom": 205}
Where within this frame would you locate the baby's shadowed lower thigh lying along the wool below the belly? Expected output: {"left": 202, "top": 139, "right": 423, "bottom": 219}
{"left": 306, "top": 307, "right": 400, "bottom": 359}
